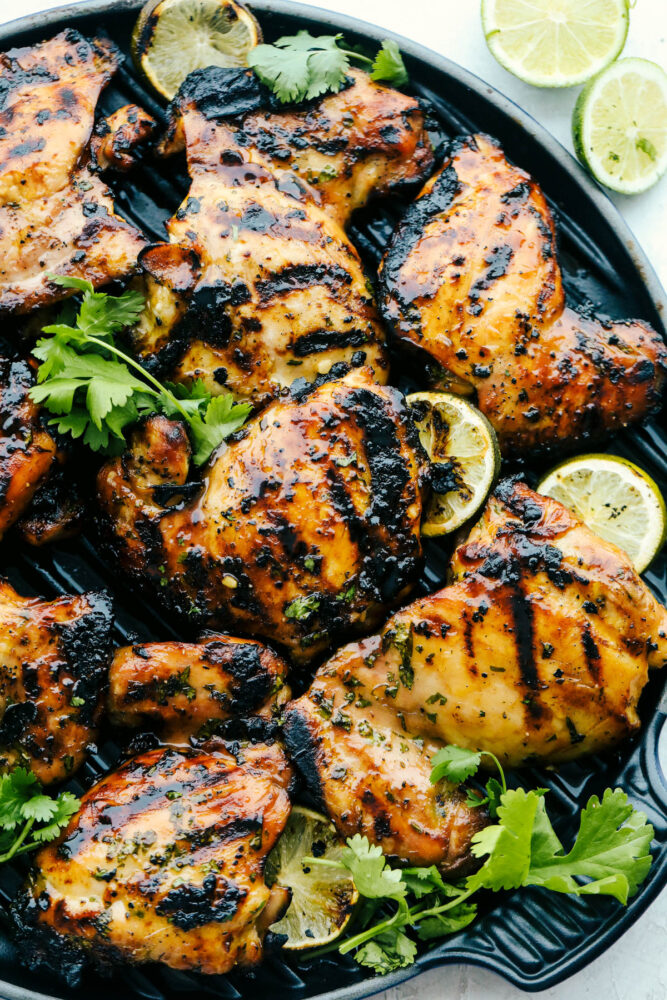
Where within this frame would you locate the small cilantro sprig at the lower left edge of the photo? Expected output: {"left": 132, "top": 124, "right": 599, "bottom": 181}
{"left": 0, "top": 767, "right": 79, "bottom": 864}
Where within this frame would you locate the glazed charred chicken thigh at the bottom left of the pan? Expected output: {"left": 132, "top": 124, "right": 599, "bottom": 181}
{"left": 14, "top": 744, "right": 291, "bottom": 985}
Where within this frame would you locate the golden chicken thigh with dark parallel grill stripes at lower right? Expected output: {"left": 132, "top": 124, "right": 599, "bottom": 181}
{"left": 285, "top": 480, "right": 667, "bottom": 868}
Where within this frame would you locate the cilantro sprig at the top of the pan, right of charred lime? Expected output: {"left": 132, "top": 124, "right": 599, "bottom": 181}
{"left": 248, "top": 31, "right": 408, "bottom": 104}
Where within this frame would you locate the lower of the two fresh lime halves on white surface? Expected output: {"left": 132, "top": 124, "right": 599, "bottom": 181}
{"left": 572, "top": 59, "right": 667, "bottom": 194}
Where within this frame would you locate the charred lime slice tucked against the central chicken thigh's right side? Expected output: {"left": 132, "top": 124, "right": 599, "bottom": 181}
{"left": 406, "top": 392, "right": 500, "bottom": 536}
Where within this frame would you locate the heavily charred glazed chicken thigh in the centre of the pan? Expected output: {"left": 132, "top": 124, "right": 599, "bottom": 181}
{"left": 98, "top": 369, "right": 422, "bottom": 661}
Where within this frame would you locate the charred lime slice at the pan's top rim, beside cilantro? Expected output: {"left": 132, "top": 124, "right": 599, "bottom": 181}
{"left": 131, "top": 0, "right": 262, "bottom": 101}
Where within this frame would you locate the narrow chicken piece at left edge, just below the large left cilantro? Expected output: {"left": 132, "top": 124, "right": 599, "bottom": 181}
{"left": 0, "top": 358, "right": 58, "bottom": 538}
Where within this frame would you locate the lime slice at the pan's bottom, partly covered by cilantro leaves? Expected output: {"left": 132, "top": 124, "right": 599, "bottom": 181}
{"left": 265, "top": 806, "right": 359, "bottom": 951}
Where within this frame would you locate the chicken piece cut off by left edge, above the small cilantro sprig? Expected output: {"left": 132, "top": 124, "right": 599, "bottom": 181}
{"left": 0, "top": 580, "right": 112, "bottom": 785}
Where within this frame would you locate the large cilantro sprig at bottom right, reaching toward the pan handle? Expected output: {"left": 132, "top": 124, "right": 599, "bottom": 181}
{"left": 303, "top": 746, "right": 653, "bottom": 974}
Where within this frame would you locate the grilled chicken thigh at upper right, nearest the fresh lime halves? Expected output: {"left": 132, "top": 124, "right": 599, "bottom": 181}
{"left": 381, "top": 135, "right": 667, "bottom": 454}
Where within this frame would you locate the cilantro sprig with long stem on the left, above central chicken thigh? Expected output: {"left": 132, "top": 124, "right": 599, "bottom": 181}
{"left": 30, "top": 276, "right": 251, "bottom": 465}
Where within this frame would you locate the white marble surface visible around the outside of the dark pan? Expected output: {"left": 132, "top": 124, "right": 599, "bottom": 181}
{"left": 0, "top": 0, "right": 667, "bottom": 1000}
